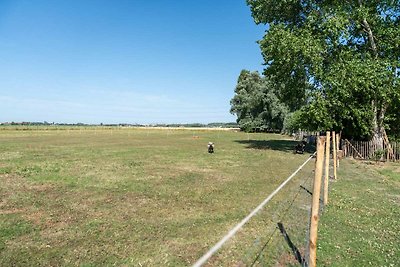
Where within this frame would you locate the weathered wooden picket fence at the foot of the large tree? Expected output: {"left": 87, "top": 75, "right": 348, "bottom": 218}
{"left": 340, "top": 139, "right": 400, "bottom": 161}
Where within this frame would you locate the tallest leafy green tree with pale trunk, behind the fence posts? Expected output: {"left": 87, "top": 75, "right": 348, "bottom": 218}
{"left": 247, "top": 0, "right": 400, "bottom": 144}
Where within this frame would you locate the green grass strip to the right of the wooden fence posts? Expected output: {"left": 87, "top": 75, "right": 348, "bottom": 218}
{"left": 317, "top": 160, "right": 400, "bottom": 266}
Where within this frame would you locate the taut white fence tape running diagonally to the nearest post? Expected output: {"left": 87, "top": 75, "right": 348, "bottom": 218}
{"left": 193, "top": 153, "right": 316, "bottom": 267}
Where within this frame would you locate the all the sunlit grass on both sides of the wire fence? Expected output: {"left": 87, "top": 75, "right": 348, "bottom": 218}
{"left": 0, "top": 127, "right": 400, "bottom": 266}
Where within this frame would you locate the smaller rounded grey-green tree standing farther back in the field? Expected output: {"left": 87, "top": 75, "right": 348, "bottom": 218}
{"left": 231, "top": 70, "right": 288, "bottom": 131}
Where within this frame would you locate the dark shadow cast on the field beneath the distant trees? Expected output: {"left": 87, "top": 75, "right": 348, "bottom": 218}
{"left": 235, "top": 140, "right": 315, "bottom": 153}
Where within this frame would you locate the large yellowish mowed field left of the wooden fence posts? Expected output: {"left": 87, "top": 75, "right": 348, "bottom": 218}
{"left": 0, "top": 128, "right": 313, "bottom": 266}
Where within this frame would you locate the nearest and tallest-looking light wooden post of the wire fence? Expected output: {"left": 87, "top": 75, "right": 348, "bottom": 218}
{"left": 308, "top": 136, "right": 326, "bottom": 267}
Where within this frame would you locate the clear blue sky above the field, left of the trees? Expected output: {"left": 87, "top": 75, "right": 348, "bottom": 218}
{"left": 0, "top": 0, "right": 265, "bottom": 123}
